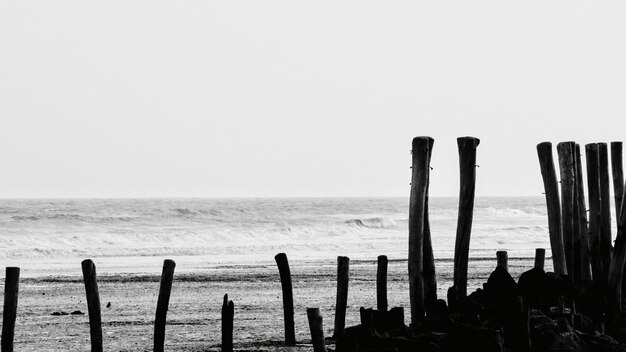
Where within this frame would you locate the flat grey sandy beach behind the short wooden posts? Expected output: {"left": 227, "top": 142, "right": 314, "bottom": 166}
{"left": 6, "top": 256, "right": 549, "bottom": 351}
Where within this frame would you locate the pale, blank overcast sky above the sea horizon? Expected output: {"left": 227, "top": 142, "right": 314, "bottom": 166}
{"left": 0, "top": 0, "right": 626, "bottom": 198}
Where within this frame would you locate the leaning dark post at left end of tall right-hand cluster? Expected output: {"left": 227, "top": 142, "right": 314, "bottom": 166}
{"left": 537, "top": 142, "right": 567, "bottom": 274}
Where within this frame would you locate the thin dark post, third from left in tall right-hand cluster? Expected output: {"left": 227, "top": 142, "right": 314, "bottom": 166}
{"left": 574, "top": 144, "right": 591, "bottom": 281}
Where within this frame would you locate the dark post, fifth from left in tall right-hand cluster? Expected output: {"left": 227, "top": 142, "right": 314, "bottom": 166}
{"left": 598, "top": 143, "right": 619, "bottom": 280}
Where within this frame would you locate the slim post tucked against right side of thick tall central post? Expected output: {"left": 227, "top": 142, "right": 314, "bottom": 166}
{"left": 423, "top": 137, "right": 437, "bottom": 310}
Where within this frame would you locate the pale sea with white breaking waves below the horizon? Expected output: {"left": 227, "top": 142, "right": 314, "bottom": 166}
{"left": 0, "top": 197, "right": 550, "bottom": 277}
